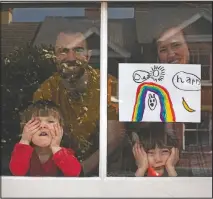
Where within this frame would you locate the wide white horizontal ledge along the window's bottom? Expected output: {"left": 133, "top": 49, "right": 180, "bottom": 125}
{"left": 1, "top": 177, "right": 212, "bottom": 198}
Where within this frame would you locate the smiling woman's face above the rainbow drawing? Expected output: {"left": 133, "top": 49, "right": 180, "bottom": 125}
{"left": 157, "top": 28, "right": 189, "bottom": 64}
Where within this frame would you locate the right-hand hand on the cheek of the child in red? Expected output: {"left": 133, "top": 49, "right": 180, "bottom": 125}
{"left": 50, "top": 123, "right": 63, "bottom": 154}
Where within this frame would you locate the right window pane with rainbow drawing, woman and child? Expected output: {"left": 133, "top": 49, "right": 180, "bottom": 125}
{"left": 107, "top": 2, "right": 212, "bottom": 177}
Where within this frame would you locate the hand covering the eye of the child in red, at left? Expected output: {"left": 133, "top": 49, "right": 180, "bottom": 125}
{"left": 20, "top": 118, "right": 40, "bottom": 144}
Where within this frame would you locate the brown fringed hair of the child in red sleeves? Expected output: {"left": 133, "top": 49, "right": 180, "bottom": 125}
{"left": 20, "top": 100, "right": 64, "bottom": 129}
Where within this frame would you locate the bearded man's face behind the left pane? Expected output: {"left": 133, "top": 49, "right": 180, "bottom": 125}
{"left": 55, "top": 33, "right": 91, "bottom": 81}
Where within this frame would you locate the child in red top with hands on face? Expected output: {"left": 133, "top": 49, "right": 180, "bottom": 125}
{"left": 9, "top": 101, "right": 81, "bottom": 177}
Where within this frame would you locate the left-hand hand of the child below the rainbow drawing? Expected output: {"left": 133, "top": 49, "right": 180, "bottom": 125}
{"left": 133, "top": 142, "right": 149, "bottom": 173}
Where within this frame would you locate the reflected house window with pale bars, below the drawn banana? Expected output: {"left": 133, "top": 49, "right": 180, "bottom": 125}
{"left": 185, "top": 111, "right": 212, "bottom": 150}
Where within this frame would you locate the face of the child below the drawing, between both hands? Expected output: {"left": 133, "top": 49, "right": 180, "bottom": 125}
{"left": 147, "top": 147, "right": 170, "bottom": 175}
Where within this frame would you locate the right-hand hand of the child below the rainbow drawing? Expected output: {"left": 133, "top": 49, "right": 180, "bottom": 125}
{"left": 165, "top": 147, "right": 179, "bottom": 176}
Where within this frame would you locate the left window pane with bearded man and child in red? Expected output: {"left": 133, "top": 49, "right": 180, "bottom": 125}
{"left": 1, "top": 4, "right": 100, "bottom": 176}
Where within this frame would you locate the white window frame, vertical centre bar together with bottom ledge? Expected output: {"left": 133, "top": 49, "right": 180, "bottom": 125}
{"left": 1, "top": 0, "right": 212, "bottom": 198}
